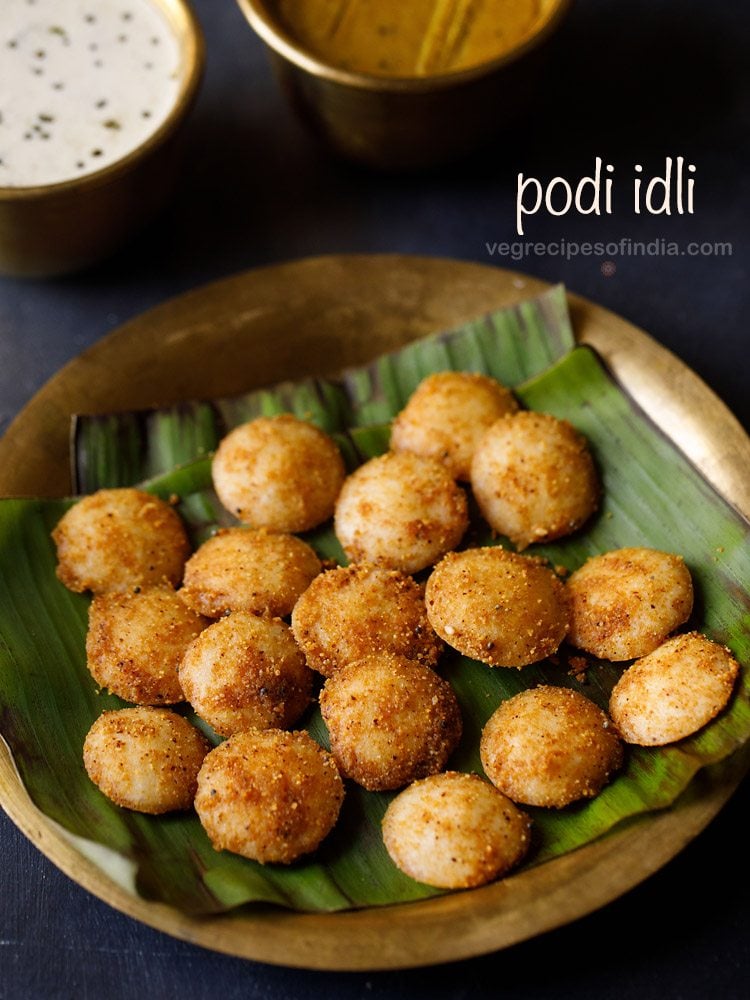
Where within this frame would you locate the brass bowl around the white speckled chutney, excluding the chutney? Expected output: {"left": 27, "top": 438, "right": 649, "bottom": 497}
{"left": 0, "top": 0, "right": 205, "bottom": 277}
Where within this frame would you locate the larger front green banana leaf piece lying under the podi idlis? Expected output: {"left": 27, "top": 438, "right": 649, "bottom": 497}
{"left": 0, "top": 338, "right": 750, "bottom": 913}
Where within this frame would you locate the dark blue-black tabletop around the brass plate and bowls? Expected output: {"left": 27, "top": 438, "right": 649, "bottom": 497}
{"left": 0, "top": 0, "right": 750, "bottom": 1000}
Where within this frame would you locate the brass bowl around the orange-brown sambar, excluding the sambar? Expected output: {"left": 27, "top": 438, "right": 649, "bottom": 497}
{"left": 237, "top": 0, "right": 571, "bottom": 170}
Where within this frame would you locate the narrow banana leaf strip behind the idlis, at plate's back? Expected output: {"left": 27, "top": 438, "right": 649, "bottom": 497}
{"left": 71, "top": 285, "right": 575, "bottom": 493}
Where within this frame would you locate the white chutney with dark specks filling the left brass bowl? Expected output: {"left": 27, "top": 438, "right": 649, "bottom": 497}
{"left": 0, "top": 0, "right": 182, "bottom": 187}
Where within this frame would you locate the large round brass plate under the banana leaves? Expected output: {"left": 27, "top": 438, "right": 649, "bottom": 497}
{"left": 0, "top": 255, "right": 750, "bottom": 970}
